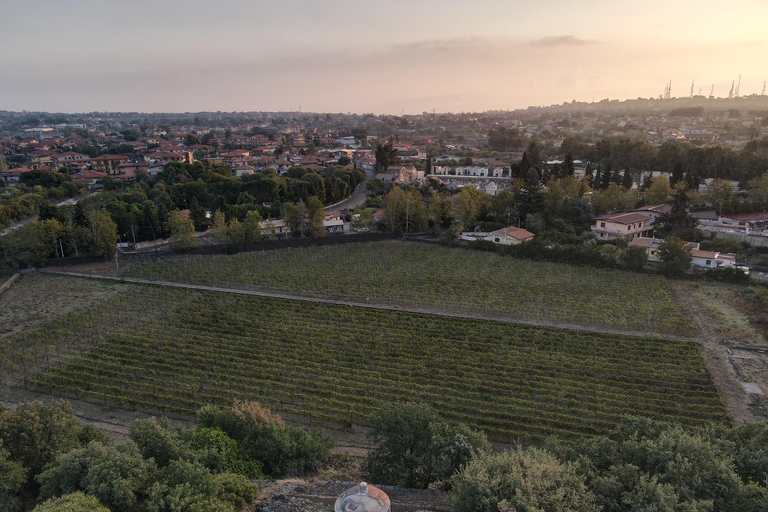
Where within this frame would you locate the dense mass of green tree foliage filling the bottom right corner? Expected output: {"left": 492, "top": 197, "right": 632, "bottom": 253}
{"left": 563, "top": 418, "right": 768, "bottom": 512}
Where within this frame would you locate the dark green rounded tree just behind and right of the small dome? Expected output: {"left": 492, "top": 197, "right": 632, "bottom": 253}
{"left": 367, "top": 402, "right": 490, "bottom": 488}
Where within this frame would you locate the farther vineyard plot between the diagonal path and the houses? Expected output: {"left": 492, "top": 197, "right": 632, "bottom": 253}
{"left": 120, "top": 242, "right": 691, "bottom": 336}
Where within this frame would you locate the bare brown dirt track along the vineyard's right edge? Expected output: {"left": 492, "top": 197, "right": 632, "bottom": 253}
{"left": 670, "top": 281, "right": 761, "bottom": 424}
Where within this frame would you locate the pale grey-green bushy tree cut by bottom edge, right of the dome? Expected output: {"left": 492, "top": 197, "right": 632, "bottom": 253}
{"left": 451, "top": 447, "right": 600, "bottom": 512}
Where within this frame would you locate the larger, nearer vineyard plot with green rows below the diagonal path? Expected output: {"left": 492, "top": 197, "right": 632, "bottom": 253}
{"left": 0, "top": 278, "right": 725, "bottom": 441}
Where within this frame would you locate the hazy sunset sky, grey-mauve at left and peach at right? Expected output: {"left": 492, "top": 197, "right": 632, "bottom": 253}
{"left": 0, "top": 0, "right": 768, "bottom": 114}
